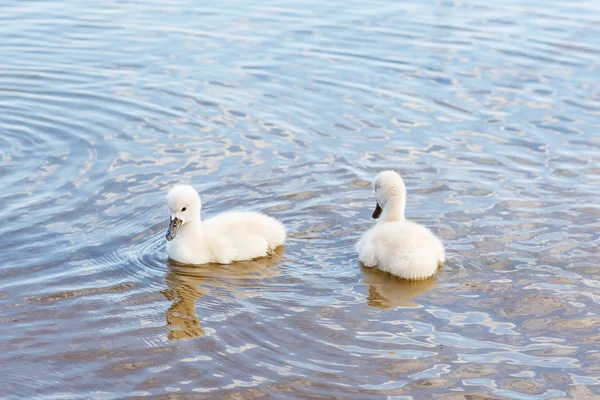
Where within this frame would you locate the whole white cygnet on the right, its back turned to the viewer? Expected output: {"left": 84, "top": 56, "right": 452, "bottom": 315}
{"left": 356, "top": 171, "right": 446, "bottom": 279}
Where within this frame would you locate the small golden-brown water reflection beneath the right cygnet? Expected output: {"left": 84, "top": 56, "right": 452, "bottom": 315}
{"left": 361, "top": 266, "right": 437, "bottom": 309}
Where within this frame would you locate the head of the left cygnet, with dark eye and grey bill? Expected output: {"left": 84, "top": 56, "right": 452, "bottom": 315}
{"left": 167, "top": 185, "right": 202, "bottom": 241}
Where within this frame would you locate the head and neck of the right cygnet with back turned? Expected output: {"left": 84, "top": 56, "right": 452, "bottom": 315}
{"left": 373, "top": 171, "right": 406, "bottom": 222}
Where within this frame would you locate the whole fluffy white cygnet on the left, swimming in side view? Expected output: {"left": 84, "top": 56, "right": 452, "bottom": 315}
{"left": 166, "top": 185, "right": 286, "bottom": 264}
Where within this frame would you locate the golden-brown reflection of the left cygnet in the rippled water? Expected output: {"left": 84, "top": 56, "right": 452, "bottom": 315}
{"left": 161, "top": 250, "right": 283, "bottom": 340}
